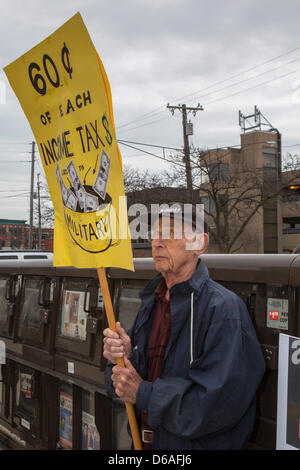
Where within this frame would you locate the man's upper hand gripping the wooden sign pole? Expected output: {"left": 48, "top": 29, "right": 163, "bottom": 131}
{"left": 103, "top": 322, "right": 131, "bottom": 364}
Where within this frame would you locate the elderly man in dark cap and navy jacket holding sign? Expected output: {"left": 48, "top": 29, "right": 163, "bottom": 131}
{"left": 104, "top": 206, "right": 265, "bottom": 450}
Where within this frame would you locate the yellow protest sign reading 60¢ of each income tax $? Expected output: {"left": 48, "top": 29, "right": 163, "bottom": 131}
{"left": 4, "top": 13, "right": 133, "bottom": 270}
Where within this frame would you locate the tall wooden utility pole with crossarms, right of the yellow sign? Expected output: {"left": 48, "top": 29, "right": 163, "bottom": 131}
{"left": 167, "top": 103, "right": 203, "bottom": 201}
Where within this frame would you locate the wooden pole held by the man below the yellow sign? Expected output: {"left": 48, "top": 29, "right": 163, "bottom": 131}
{"left": 97, "top": 268, "right": 142, "bottom": 450}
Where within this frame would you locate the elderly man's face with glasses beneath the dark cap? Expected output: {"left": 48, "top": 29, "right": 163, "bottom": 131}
{"left": 152, "top": 219, "right": 207, "bottom": 275}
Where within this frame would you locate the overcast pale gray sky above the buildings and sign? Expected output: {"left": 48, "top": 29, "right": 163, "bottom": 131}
{"left": 0, "top": 0, "right": 300, "bottom": 221}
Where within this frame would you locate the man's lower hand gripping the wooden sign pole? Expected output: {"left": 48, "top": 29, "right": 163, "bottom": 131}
{"left": 111, "top": 357, "right": 143, "bottom": 405}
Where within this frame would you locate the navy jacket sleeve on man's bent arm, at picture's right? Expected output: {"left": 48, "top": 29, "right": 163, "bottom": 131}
{"left": 136, "top": 299, "right": 265, "bottom": 439}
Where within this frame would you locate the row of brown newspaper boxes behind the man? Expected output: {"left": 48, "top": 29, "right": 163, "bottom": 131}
{"left": 0, "top": 255, "right": 300, "bottom": 450}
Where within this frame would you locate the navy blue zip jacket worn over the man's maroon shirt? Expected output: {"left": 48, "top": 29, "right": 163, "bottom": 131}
{"left": 105, "top": 261, "right": 265, "bottom": 450}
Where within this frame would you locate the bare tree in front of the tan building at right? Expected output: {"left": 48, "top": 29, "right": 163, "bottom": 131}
{"left": 164, "top": 148, "right": 300, "bottom": 253}
